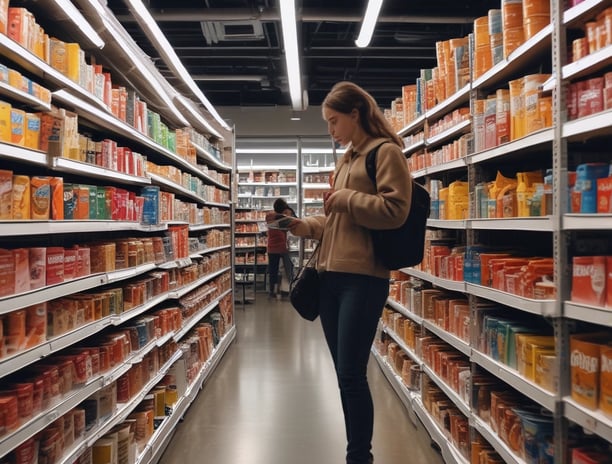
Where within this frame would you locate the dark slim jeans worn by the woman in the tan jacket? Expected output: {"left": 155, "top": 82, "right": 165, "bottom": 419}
{"left": 320, "top": 272, "right": 389, "bottom": 464}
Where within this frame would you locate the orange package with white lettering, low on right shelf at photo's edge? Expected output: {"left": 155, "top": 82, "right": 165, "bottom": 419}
{"left": 570, "top": 332, "right": 612, "bottom": 410}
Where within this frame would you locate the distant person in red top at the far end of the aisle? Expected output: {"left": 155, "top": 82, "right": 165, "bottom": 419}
{"left": 266, "top": 198, "right": 295, "bottom": 297}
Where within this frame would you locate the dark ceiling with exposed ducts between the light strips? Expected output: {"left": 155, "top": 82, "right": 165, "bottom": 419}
{"left": 108, "top": 0, "right": 492, "bottom": 111}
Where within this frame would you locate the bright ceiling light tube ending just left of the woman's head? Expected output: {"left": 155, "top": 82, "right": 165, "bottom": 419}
{"left": 280, "top": 0, "right": 304, "bottom": 111}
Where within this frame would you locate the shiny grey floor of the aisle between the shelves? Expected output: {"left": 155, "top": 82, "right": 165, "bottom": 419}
{"left": 160, "top": 294, "right": 443, "bottom": 464}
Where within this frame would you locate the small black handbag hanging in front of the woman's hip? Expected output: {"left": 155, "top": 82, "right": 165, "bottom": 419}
{"left": 289, "top": 244, "right": 319, "bottom": 321}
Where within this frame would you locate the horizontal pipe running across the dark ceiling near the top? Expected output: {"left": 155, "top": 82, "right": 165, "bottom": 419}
{"left": 117, "top": 8, "right": 474, "bottom": 24}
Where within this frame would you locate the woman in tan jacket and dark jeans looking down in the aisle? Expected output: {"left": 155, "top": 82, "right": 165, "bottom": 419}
{"left": 290, "top": 82, "right": 412, "bottom": 464}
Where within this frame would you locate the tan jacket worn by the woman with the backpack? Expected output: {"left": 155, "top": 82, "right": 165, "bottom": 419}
{"left": 303, "top": 138, "right": 412, "bottom": 278}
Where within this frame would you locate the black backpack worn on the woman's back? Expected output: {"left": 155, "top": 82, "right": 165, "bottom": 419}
{"left": 366, "top": 145, "right": 431, "bottom": 269}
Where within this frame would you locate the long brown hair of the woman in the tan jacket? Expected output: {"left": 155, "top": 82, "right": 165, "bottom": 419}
{"left": 322, "top": 81, "right": 404, "bottom": 148}
